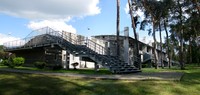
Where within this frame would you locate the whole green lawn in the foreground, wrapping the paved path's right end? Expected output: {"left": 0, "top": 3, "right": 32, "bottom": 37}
{"left": 0, "top": 67, "right": 200, "bottom": 95}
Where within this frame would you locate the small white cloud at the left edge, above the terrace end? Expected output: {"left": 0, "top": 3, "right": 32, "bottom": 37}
{"left": 0, "top": 33, "right": 20, "bottom": 45}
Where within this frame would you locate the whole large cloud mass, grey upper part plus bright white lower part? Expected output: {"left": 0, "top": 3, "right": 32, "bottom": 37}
{"left": 0, "top": 0, "right": 101, "bottom": 33}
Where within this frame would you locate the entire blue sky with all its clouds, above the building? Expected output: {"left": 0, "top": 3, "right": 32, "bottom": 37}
{"left": 0, "top": 0, "right": 164, "bottom": 45}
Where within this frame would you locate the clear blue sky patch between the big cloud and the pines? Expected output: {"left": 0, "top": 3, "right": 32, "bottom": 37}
{"left": 71, "top": 0, "right": 131, "bottom": 35}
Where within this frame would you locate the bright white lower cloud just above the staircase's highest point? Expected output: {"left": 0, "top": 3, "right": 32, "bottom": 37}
{"left": 28, "top": 20, "right": 76, "bottom": 33}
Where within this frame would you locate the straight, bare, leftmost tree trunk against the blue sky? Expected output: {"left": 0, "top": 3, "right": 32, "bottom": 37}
{"left": 116, "top": 0, "right": 120, "bottom": 57}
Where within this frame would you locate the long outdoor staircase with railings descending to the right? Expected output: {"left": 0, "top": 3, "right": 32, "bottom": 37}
{"left": 3, "top": 27, "right": 140, "bottom": 74}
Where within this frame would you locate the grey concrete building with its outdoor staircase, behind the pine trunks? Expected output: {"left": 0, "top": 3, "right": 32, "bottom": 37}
{"left": 4, "top": 28, "right": 172, "bottom": 72}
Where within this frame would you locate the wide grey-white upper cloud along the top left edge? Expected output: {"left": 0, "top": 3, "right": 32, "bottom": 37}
{"left": 0, "top": 0, "right": 101, "bottom": 20}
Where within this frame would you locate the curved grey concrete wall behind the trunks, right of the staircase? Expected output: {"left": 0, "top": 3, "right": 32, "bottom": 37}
{"left": 95, "top": 35, "right": 167, "bottom": 67}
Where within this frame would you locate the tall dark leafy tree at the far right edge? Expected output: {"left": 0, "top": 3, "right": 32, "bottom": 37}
{"left": 184, "top": 0, "right": 200, "bottom": 63}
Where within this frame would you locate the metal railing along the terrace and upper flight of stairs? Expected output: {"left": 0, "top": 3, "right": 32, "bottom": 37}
{"left": 4, "top": 27, "right": 109, "bottom": 55}
